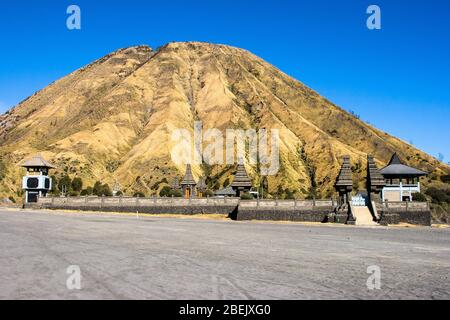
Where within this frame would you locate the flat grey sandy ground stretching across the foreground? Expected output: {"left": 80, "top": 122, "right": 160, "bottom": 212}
{"left": 0, "top": 209, "right": 450, "bottom": 299}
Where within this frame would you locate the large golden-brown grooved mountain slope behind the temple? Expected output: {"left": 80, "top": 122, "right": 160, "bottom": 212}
{"left": 0, "top": 42, "right": 450, "bottom": 197}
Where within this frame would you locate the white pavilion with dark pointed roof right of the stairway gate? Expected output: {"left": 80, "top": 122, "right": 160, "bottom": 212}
{"left": 380, "top": 153, "right": 428, "bottom": 201}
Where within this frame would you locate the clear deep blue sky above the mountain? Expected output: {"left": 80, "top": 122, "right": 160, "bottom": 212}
{"left": 0, "top": 0, "right": 450, "bottom": 162}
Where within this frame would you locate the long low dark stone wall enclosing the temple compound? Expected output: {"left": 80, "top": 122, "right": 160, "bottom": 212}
{"left": 34, "top": 197, "right": 431, "bottom": 226}
